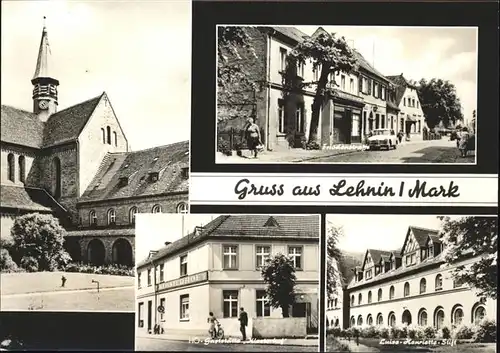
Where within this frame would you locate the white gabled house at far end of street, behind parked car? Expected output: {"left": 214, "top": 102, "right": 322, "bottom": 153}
{"left": 387, "top": 74, "right": 426, "bottom": 141}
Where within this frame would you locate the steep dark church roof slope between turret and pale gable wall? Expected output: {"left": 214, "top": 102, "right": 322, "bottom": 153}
{"left": 43, "top": 92, "right": 106, "bottom": 147}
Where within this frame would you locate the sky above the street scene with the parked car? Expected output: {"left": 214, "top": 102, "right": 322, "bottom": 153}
{"left": 297, "top": 26, "right": 477, "bottom": 123}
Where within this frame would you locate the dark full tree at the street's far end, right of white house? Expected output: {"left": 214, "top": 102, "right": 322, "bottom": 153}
{"left": 417, "top": 78, "right": 464, "bottom": 129}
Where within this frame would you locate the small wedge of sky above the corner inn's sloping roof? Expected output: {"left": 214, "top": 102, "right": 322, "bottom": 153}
{"left": 135, "top": 213, "right": 219, "bottom": 262}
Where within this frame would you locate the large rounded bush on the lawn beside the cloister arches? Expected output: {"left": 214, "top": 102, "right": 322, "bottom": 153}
{"left": 10, "top": 213, "right": 71, "bottom": 271}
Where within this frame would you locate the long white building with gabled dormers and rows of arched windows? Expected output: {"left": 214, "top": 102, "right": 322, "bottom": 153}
{"left": 343, "top": 226, "right": 497, "bottom": 329}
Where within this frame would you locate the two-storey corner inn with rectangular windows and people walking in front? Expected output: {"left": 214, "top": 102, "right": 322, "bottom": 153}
{"left": 136, "top": 215, "right": 320, "bottom": 337}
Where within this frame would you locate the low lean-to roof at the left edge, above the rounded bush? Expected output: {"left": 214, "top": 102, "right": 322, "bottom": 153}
{"left": 0, "top": 184, "right": 65, "bottom": 212}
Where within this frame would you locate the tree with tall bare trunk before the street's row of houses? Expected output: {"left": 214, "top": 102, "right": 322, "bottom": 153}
{"left": 287, "top": 28, "right": 357, "bottom": 144}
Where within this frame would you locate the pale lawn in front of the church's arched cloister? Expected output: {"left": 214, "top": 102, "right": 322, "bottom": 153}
{"left": 0, "top": 272, "right": 135, "bottom": 311}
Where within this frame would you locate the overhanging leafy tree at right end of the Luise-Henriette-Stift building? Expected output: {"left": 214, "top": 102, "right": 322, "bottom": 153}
{"left": 440, "top": 216, "right": 498, "bottom": 299}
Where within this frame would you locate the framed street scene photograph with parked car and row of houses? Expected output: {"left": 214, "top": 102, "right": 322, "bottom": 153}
{"left": 216, "top": 24, "right": 478, "bottom": 165}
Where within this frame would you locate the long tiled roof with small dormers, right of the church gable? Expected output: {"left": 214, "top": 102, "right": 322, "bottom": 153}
{"left": 80, "top": 141, "right": 189, "bottom": 202}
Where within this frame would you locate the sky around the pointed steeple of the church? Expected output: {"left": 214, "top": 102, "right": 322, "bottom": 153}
{"left": 1, "top": 0, "right": 191, "bottom": 150}
